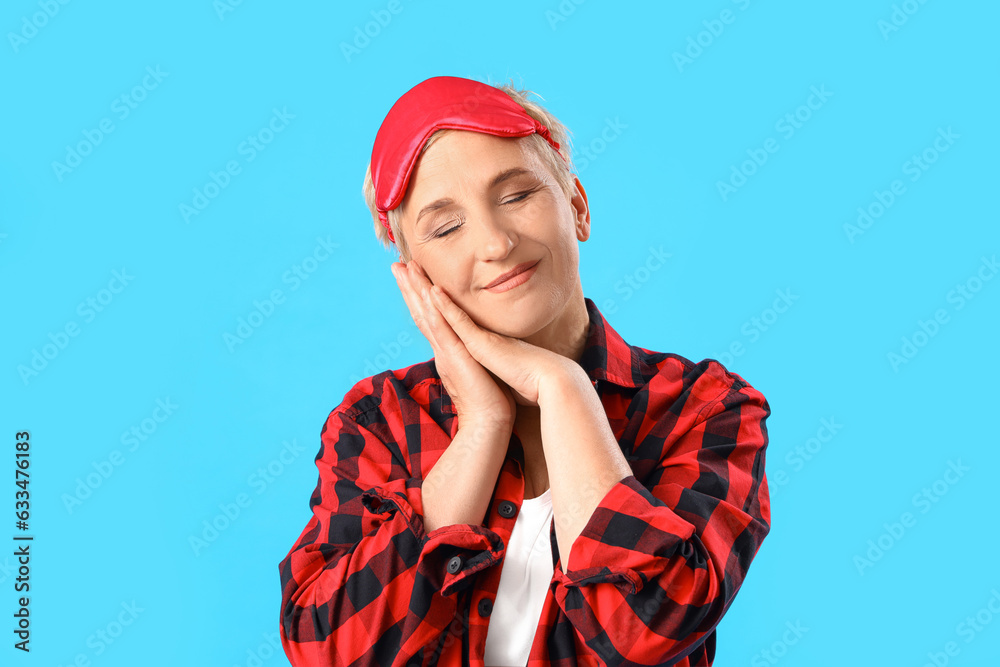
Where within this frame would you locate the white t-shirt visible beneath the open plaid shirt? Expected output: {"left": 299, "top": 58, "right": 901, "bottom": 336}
{"left": 485, "top": 487, "right": 553, "bottom": 667}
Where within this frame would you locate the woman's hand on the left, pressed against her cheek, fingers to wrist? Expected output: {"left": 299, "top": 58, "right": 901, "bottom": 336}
{"left": 390, "top": 259, "right": 517, "bottom": 432}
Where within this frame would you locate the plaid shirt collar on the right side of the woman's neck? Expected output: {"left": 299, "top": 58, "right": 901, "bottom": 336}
{"left": 579, "top": 297, "right": 657, "bottom": 389}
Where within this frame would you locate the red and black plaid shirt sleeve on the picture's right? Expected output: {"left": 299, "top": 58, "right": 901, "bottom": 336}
{"left": 555, "top": 361, "right": 771, "bottom": 666}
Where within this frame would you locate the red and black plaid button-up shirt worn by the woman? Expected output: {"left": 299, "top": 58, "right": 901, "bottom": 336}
{"left": 279, "top": 299, "right": 771, "bottom": 667}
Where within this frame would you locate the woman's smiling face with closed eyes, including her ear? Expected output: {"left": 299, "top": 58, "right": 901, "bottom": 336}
{"left": 400, "top": 131, "right": 590, "bottom": 338}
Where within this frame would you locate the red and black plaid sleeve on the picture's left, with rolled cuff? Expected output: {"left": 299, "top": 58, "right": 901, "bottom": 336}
{"left": 279, "top": 400, "right": 503, "bottom": 667}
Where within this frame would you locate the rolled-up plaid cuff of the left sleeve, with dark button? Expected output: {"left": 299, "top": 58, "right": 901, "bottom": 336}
{"left": 361, "top": 477, "right": 506, "bottom": 595}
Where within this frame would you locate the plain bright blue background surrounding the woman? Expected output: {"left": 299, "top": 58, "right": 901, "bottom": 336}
{"left": 0, "top": 0, "right": 1000, "bottom": 667}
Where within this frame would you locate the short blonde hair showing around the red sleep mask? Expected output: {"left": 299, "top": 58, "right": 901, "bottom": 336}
{"left": 363, "top": 80, "right": 575, "bottom": 262}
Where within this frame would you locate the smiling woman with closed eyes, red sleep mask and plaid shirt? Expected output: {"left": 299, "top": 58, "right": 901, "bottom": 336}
{"left": 280, "top": 77, "right": 770, "bottom": 667}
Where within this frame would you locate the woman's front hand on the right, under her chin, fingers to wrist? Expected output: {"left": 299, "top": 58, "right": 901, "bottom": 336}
{"left": 430, "top": 285, "right": 583, "bottom": 406}
